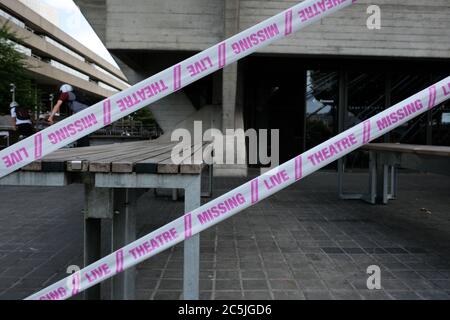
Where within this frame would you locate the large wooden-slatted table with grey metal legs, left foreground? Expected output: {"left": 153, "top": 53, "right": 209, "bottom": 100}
{"left": 0, "top": 141, "right": 212, "bottom": 299}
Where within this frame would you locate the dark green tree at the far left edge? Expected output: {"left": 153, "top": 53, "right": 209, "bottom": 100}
{"left": 0, "top": 23, "right": 35, "bottom": 114}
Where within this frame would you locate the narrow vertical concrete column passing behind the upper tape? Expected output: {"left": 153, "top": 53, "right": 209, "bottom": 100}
{"left": 222, "top": 0, "right": 240, "bottom": 131}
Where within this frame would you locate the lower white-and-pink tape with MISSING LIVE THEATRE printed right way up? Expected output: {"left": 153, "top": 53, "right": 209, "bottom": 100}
{"left": 27, "top": 77, "right": 450, "bottom": 300}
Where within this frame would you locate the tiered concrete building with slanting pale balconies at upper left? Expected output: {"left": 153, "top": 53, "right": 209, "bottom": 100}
{"left": 0, "top": 0, "right": 129, "bottom": 107}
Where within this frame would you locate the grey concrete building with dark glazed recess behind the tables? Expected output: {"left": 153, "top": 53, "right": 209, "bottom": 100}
{"left": 75, "top": 0, "right": 450, "bottom": 172}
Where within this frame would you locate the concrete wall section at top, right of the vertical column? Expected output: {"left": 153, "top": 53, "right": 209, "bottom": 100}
{"left": 239, "top": 0, "right": 450, "bottom": 58}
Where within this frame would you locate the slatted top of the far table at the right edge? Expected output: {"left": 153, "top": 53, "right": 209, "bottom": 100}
{"left": 362, "top": 143, "right": 450, "bottom": 157}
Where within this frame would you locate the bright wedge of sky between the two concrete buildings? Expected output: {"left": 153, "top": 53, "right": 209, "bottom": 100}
{"left": 23, "top": 0, "right": 117, "bottom": 66}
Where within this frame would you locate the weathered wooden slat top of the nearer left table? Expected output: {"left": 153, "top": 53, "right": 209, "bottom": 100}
{"left": 22, "top": 141, "right": 208, "bottom": 174}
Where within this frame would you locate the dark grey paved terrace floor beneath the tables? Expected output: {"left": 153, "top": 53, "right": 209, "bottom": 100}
{"left": 0, "top": 172, "right": 450, "bottom": 299}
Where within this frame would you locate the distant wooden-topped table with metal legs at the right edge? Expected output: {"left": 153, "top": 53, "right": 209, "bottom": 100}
{"left": 339, "top": 143, "right": 450, "bottom": 204}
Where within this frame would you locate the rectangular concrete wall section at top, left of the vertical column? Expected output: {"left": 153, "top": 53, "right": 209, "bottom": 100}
{"left": 106, "top": 0, "right": 223, "bottom": 50}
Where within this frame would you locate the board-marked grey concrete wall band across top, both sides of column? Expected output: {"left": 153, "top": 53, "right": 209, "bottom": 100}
{"left": 90, "top": 0, "right": 450, "bottom": 58}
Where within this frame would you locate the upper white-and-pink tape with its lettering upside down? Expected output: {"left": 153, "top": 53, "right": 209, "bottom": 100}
{"left": 0, "top": 0, "right": 356, "bottom": 178}
